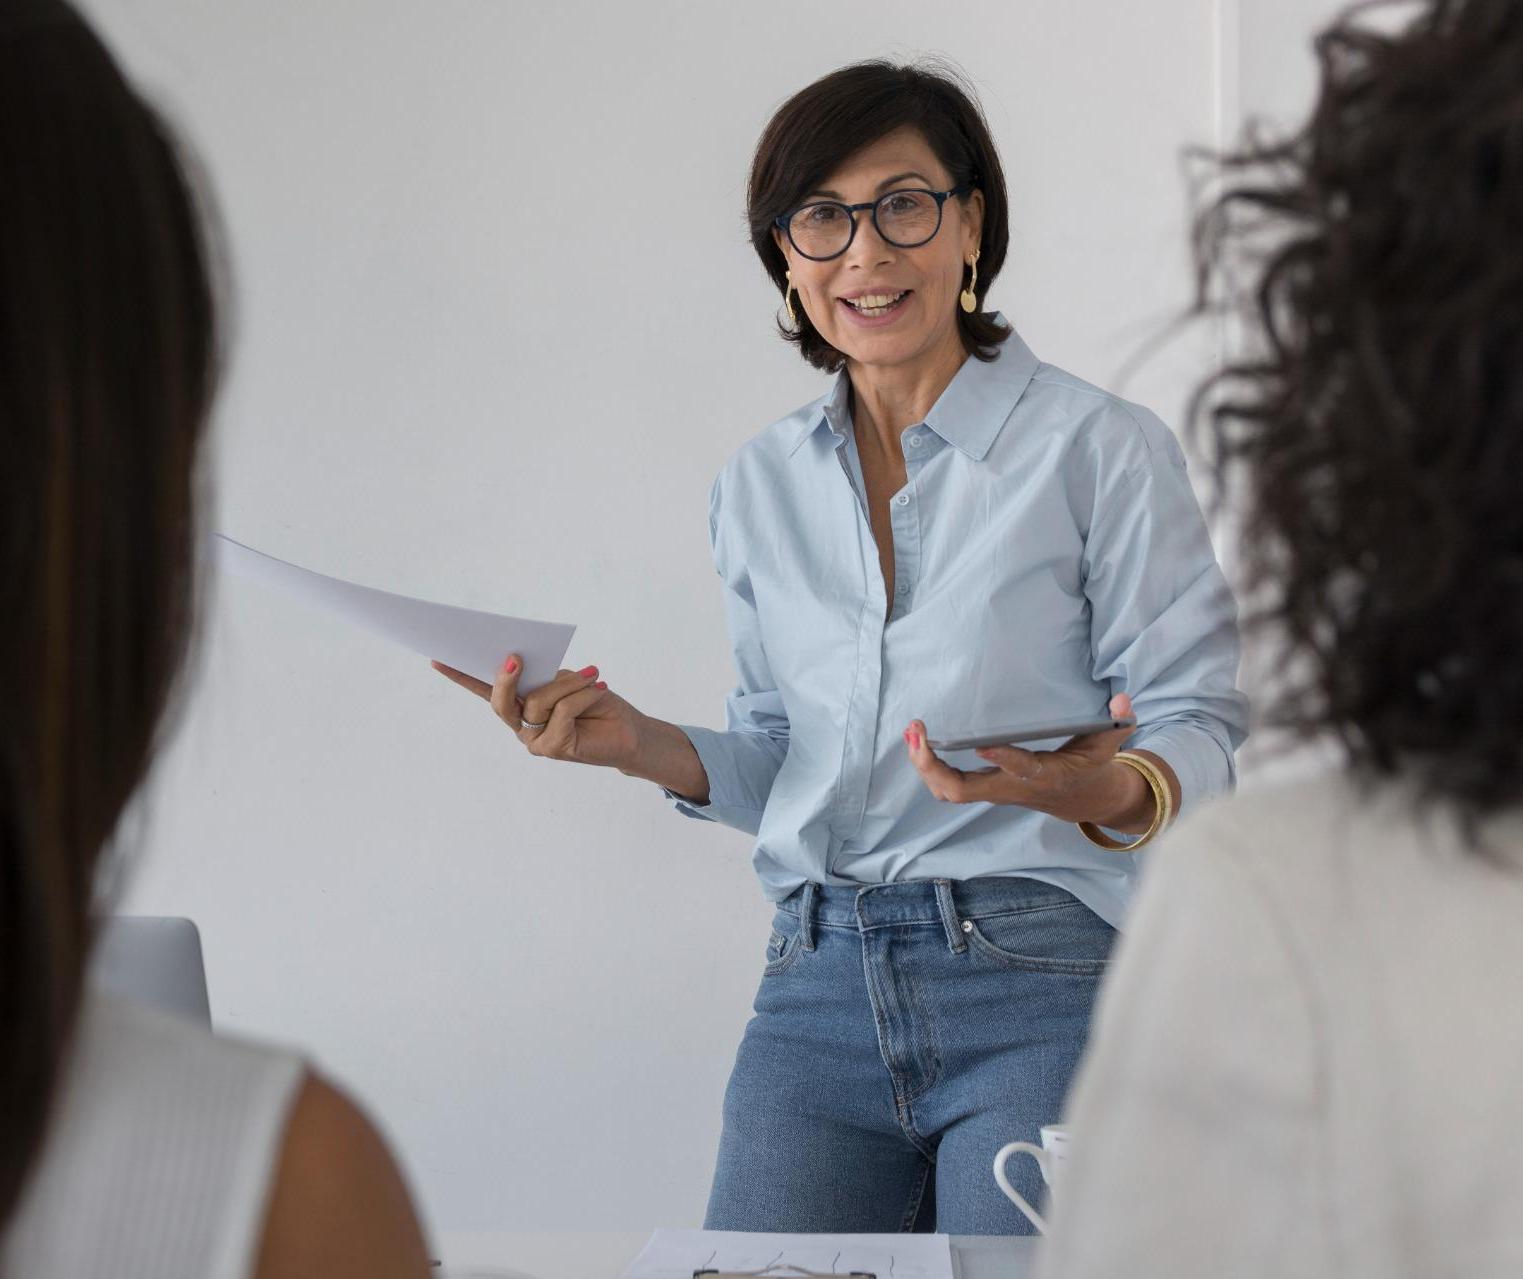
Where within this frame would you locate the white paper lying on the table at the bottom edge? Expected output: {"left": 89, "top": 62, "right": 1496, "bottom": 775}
{"left": 620, "top": 1230, "right": 952, "bottom": 1279}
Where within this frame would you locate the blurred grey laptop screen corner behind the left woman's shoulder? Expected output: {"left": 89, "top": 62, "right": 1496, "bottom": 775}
{"left": 88, "top": 915, "right": 212, "bottom": 1026}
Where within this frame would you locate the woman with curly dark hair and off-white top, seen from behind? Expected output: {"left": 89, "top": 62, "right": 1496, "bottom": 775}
{"left": 1043, "top": 0, "right": 1523, "bottom": 1279}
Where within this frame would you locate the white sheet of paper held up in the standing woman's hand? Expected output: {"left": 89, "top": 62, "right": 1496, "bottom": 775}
{"left": 215, "top": 533, "right": 576, "bottom": 688}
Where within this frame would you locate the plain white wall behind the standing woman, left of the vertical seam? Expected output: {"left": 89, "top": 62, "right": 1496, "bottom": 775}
{"left": 77, "top": 0, "right": 1315, "bottom": 1230}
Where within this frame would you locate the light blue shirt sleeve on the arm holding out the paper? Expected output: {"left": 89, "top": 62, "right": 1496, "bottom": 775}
{"left": 664, "top": 477, "right": 787, "bottom": 834}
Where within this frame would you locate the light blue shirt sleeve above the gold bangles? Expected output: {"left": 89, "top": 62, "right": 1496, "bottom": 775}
{"left": 1084, "top": 410, "right": 1247, "bottom": 807}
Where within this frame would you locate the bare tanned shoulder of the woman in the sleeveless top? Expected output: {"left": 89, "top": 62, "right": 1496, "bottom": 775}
{"left": 253, "top": 1073, "right": 428, "bottom": 1279}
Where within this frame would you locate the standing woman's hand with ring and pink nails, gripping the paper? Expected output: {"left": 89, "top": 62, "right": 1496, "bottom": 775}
{"left": 433, "top": 653, "right": 641, "bottom": 767}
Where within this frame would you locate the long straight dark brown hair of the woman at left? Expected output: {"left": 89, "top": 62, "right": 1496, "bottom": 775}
{"left": 0, "top": 0, "right": 218, "bottom": 1233}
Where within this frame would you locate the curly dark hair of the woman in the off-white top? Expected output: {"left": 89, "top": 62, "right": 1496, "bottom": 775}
{"left": 1196, "top": 0, "right": 1523, "bottom": 834}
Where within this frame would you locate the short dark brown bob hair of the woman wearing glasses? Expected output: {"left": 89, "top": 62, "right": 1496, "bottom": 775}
{"left": 746, "top": 61, "right": 1010, "bottom": 373}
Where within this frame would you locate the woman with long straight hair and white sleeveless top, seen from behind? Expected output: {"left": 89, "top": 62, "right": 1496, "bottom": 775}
{"left": 0, "top": 0, "right": 428, "bottom": 1279}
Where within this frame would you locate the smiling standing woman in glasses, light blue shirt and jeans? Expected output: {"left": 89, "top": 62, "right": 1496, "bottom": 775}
{"left": 445, "top": 62, "right": 1244, "bottom": 1233}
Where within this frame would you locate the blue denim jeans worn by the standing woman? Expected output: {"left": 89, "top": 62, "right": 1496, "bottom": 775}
{"left": 705, "top": 877, "right": 1115, "bottom": 1235}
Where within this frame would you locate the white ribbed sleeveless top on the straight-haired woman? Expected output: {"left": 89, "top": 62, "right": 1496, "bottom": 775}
{"left": 0, "top": 993, "right": 306, "bottom": 1279}
